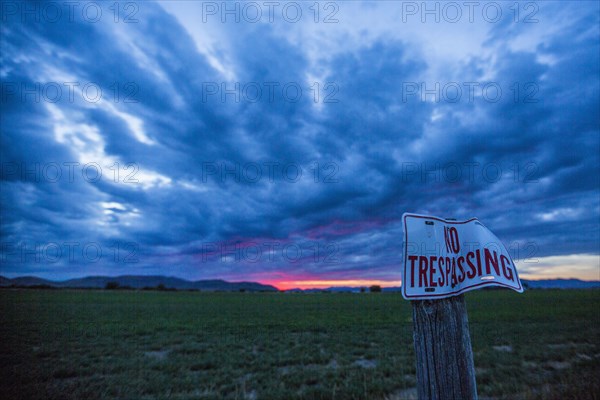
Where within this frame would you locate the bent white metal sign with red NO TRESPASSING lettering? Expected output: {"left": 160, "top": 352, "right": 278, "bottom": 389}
{"left": 402, "top": 213, "right": 523, "bottom": 300}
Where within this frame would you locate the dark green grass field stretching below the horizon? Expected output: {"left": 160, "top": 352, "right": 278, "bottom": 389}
{"left": 0, "top": 290, "right": 600, "bottom": 400}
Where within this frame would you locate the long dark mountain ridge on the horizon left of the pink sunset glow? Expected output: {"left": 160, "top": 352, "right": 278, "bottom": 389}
{"left": 0, "top": 275, "right": 278, "bottom": 292}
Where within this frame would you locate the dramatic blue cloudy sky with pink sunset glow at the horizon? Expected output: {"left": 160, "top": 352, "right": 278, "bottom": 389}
{"left": 0, "top": 1, "right": 600, "bottom": 288}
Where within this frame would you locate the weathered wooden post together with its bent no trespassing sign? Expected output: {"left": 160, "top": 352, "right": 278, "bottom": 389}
{"left": 402, "top": 213, "right": 523, "bottom": 400}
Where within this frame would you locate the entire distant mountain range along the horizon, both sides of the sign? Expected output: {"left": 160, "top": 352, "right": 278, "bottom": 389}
{"left": 0, "top": 275, "right": 600, "bottom": 293}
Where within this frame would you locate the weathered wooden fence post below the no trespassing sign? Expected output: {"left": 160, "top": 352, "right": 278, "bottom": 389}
{"left": 412, "top": 295, "right": 477, "bottom": 400}
